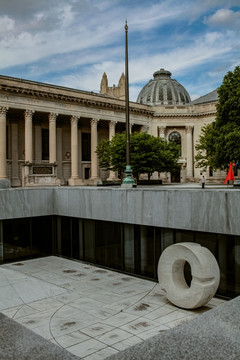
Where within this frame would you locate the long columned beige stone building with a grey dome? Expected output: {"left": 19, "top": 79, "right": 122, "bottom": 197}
{"left": 0, "top": 69, "right": 223, "bottom": 187}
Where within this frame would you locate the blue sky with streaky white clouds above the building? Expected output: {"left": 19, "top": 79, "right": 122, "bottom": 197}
{"left": 0, "top": 0, "right": 240, "bottom": 101}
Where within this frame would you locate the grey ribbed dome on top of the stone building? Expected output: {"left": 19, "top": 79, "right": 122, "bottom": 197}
{"left": 137, "top": 69, "right": 191, "bottom": 106}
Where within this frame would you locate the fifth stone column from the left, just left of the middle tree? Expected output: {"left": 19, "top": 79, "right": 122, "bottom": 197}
{"left": 89, "top": 119, "right": 101, "bottom": 185}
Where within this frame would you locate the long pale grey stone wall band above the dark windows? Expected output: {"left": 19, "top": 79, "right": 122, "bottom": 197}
{"left": 0, "top": 187, "right": 240, "bottom": 235}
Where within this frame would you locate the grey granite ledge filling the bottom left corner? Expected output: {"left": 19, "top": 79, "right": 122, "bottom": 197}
{"left": 0, "top": 313, "right": 79, "bottom": 360}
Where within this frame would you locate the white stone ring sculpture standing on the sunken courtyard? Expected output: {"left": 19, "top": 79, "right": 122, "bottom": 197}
{"left": 158, "top": 242, "right": 220, "bottom": 309}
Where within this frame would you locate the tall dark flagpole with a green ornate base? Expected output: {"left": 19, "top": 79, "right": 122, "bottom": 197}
{"left": 122, "top": 21, "right": 136, "bottom": 187}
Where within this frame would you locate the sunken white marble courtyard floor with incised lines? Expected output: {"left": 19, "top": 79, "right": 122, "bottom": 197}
{"left": 0, "top": 256, "right": 224, "bottom": 360}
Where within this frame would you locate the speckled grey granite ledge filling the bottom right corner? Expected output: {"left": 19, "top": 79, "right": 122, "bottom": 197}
{"left": 107, "top": 297, "right": 240, "bottom": 360}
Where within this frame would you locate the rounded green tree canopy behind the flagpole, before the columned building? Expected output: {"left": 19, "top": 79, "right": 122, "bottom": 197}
{"left": 96, "top": 133, "right": 179, "bottom": 179}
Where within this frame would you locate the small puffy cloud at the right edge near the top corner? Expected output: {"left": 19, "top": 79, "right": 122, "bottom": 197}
{"left": 204, "top": 9, "right": 240, "bottom": 30}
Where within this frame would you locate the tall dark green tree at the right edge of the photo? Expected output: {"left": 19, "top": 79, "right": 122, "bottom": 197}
{"left": 195, "top": 66, "right": 240, "bottom": 169}
